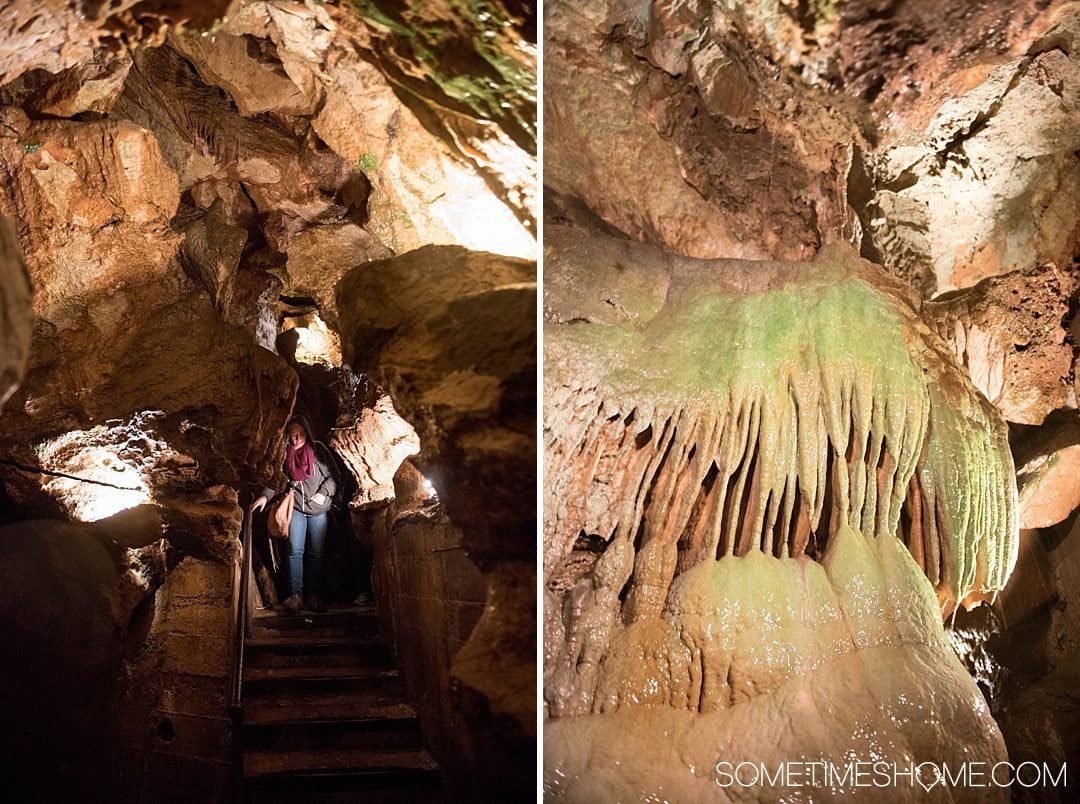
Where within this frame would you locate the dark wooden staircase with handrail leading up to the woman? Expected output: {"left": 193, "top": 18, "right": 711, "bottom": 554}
{"left": 240, "top": 606, "right": 442, "bottom": 804}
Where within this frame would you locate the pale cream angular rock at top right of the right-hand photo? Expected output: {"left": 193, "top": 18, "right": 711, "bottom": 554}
{"left": 870, "top": 6, "right": 1080, "bottom": 291}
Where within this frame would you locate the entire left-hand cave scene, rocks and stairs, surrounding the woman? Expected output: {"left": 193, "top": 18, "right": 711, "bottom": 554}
{"left": 0, "top": 0, "right": 537, "bottom": 802}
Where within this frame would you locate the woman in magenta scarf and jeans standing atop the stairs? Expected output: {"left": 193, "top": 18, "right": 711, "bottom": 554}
{"left": 252, "top": 416, "right": 338, "bottom": 612}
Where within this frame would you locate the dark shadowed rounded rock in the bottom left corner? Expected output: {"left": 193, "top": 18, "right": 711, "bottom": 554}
{"left": 0, "top": 521, "right": 133, "bottom": 801}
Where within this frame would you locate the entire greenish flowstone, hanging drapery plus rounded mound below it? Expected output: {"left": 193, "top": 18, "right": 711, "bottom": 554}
{"left": 544, "top": 227, "right": 1018, "bottom": 801}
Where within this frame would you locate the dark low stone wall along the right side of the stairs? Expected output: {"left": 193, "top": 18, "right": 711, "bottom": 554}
{"left": 369, "top": 461, "right": 536, "bottom": 802}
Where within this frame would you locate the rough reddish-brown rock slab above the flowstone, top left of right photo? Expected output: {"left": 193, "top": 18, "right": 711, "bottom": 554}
{"left": 544, "top": 1, "right": 858, "bottom": 259}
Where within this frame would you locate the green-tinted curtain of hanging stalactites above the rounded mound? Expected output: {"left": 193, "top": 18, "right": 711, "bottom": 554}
{"left": 546, "top": 245, "right": 1016, "bottom": 706}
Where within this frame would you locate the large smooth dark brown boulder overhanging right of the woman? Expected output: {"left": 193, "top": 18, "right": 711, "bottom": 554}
{"left": 337, "top": 246, "right": 536, "bottom": 566}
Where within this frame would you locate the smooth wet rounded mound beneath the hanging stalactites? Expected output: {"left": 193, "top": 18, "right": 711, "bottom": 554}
{"left": 544, "top": 528, "right": 1009, "bottom": 802}
